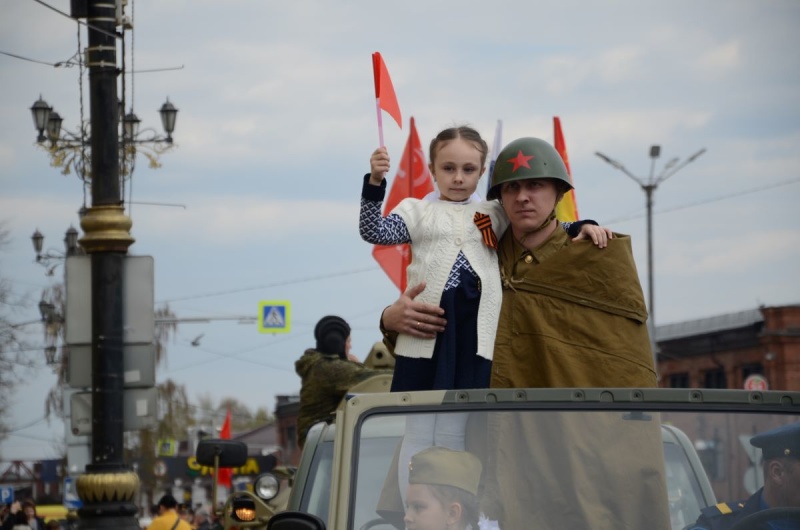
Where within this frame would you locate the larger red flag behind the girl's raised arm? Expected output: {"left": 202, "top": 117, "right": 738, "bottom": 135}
{"left": 372, "top": 117, "right": 433, "bottom": 292}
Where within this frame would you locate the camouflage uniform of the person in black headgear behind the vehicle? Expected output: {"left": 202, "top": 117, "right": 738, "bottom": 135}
{"left": 294, "top": 349, "right": 392, "bottom": 447}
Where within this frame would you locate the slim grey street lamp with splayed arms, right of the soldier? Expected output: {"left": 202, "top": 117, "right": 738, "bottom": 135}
{"left": 595, "top": 145, "right": 706, "bottom": 368}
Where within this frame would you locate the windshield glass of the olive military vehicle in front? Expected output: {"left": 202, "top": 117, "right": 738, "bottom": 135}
{"left": 348, "top": 407, "right": 799, "bottom": 530}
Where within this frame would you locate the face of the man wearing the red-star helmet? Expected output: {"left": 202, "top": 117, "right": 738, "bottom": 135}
{"left": 500, "top": 179, "right": 558, "bottom": 235}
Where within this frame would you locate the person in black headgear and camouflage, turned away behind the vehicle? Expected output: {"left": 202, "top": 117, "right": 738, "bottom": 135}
{"left": 295, "top": 316, "right": 391, "bottom": 448}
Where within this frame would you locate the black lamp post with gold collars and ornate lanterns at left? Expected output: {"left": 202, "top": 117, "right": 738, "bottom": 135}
{"left": 30, "top": 0, "right": 178, "bottom": 530}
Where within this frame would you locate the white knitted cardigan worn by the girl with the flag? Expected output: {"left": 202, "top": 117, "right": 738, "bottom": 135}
{"left": 392, "top": 199, "right": 508, "bottom": 360}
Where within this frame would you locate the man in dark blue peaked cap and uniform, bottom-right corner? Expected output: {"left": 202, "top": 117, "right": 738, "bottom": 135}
{"left": 685, "top": 423, "right": 800, "bottom": 530}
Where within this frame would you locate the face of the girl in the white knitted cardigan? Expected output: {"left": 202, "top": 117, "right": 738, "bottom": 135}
{"left": 429, "top": 138, "right": 484, "bottom": 202}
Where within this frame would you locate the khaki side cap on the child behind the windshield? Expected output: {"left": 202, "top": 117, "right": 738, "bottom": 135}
{"left": 408, "top": 447, "right": 483, "bottom": 495}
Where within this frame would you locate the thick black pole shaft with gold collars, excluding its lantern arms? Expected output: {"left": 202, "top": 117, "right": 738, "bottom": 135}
{"left": 73, "top": 0, "right": 139, "bottom": 530}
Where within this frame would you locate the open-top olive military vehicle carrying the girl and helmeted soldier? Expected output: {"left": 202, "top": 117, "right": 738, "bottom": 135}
{"left": 216, "top": 389, "right": 800, "bottom": 530}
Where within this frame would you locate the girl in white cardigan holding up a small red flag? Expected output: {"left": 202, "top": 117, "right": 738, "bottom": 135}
{"left": 359, "top": 126, "right": 508, "bottom": 392}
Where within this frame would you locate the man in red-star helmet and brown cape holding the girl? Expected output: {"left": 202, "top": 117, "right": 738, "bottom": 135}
{"left": 382, "top": 138, "right": 657, "bottom": 388}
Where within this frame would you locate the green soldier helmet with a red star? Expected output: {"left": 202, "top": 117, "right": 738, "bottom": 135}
{"left": 486, "top": 137, "right": 574, "bottom": 199}
